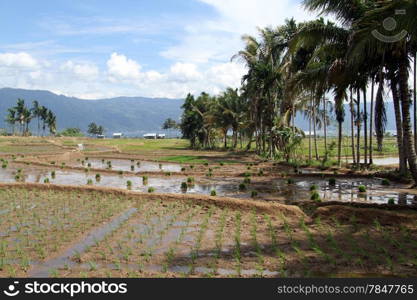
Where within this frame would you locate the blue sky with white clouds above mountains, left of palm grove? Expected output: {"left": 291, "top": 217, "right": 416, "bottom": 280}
{"left": 0, "top": 0, "right": 315, "bottom": 99}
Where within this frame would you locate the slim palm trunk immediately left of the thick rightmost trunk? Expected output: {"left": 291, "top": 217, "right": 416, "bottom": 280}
{"left": 391, "top": 79, "right": 407, "bottom": 175}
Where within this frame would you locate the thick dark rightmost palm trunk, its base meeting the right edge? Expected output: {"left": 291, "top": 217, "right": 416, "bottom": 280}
{"left": 399, "top": 55, "right": 417, "bottom": 184}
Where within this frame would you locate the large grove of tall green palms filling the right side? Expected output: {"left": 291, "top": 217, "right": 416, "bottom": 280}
{"left": 180, "top": 0, "right": 417, "bottom": 182}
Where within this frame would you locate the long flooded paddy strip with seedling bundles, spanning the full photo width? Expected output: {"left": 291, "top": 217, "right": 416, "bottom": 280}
{"left": 0, "top": 166, "right": 417, "bottom": 205}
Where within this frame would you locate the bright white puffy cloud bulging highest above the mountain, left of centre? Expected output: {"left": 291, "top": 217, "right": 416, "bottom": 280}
{"left": 107, "top": 53, "right": 142, "bottom": 80}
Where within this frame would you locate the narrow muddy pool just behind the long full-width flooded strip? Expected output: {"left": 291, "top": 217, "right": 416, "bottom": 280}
{"left": 69, "top": 158, "right": 181, "bottom": 172}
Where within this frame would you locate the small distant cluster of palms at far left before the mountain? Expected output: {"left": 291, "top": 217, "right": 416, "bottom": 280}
{"left": 6, "top": 98, "right": 57, "bottom": 136}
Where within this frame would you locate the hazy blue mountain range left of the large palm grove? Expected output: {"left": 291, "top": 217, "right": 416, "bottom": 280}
{"left": 0, "top": 88, "right": 183, "bottom": 136}
